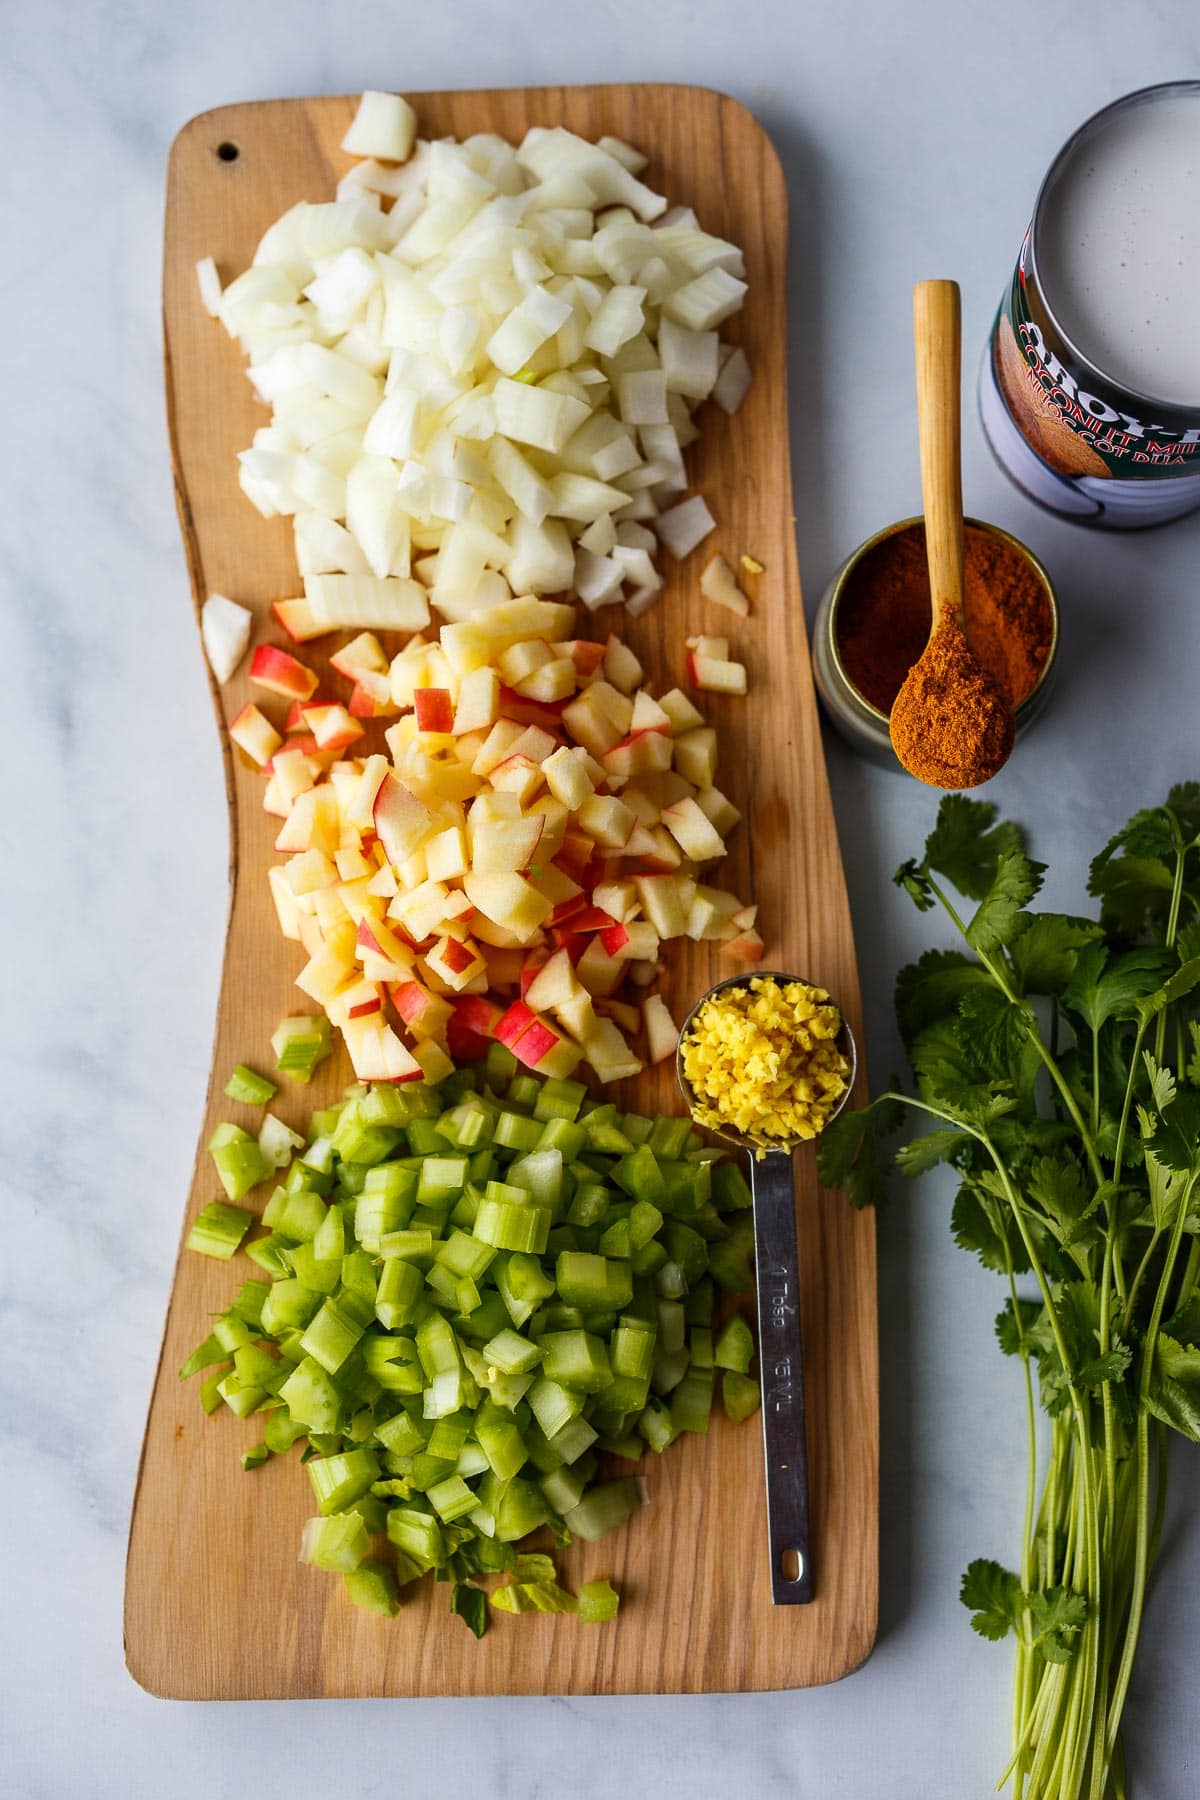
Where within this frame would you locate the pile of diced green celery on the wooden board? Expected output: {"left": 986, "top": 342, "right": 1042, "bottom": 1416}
{"left": 180, "top": 1044, "right": 759, "bottom": 1634}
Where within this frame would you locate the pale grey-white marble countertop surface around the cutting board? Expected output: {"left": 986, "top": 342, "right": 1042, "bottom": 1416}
{"left": 0, "top": 0, "right": 1200, "bottom": 1800}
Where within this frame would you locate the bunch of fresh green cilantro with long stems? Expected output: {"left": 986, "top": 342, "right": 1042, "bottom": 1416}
{"left": 820, "top": 783, "right": 1200, "bottom": 1800}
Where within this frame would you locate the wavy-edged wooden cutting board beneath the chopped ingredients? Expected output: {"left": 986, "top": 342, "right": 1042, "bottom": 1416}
{"left": 126, "top": 86, "right": 878, "bottom": 1699}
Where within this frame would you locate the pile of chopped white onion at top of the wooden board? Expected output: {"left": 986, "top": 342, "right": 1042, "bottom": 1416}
{"left": 198, "top": 94, "right": 750, "bottom": 625}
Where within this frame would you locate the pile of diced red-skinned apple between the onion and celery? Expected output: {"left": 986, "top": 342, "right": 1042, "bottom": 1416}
{"left": 230, "top": 598, "right": 763, "bottom": 1082}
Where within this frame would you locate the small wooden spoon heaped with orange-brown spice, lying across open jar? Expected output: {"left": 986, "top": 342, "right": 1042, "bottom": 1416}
{"left": 891, "top": 281, "right": 1013, "bottom": 788}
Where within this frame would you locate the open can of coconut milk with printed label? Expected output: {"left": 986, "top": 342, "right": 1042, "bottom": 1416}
{"left": 981, "top": 81, "right": 1200, "bottom": 527}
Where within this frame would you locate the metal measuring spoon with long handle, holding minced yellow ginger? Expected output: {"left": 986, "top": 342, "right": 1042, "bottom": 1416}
{"left": 675, "top": 968, "right": 858, "bottom": 1606}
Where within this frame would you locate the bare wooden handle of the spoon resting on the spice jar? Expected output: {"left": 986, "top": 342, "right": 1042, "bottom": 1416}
{"left": 912, "top": 281, "right": 963, "bottom": 630}
